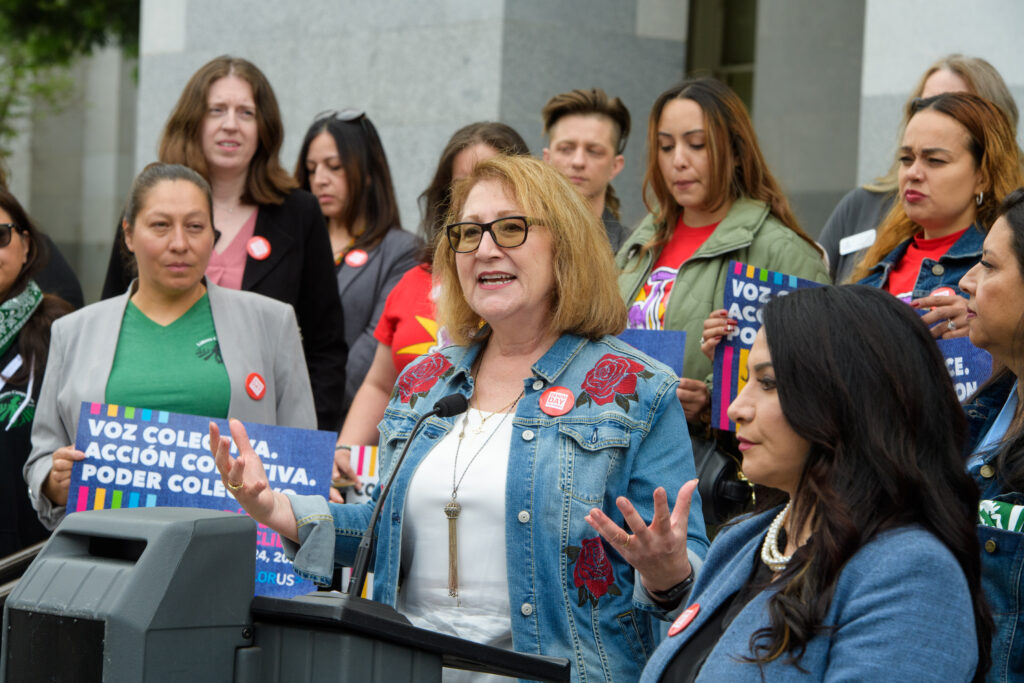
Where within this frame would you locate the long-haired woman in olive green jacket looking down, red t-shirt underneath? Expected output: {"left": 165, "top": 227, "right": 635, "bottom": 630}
{"left": 616, "top": 78, "right": 828, "bottom": 431}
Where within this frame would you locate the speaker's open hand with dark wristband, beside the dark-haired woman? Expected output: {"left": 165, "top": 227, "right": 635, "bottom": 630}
{"left": 585, "top": 479, "right": 697, "bottom": 591}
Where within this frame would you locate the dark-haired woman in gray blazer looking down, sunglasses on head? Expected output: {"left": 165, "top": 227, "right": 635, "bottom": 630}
{"left": 295, "top": 110, "right": 420, "bottom": 413}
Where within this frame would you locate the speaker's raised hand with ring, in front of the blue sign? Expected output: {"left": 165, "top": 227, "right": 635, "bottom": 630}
{"left": 210, "top": 420, "right": 299, "bottom": 542}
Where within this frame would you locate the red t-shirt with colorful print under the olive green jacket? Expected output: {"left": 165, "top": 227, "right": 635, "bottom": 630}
{"left": 627, "top": 216, "right": 722, "bottom": 330}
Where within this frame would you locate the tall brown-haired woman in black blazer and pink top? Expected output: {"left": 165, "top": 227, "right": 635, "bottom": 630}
{"left": 103, "top": 55, "right": 346, "bottom": 430}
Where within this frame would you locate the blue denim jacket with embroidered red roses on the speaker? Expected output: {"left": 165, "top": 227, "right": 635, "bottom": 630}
{"left": 287, "top": 334, "right": 709, "bottom": 681}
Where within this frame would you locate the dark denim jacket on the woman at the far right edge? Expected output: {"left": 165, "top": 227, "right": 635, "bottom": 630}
{"left": 964, "top": 375, "right": 1024, "bottom": 681}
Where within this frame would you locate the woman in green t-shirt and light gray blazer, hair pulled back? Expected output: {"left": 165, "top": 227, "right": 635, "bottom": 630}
{"left": 24, "top": 164, "right": 316, "bottom": 528}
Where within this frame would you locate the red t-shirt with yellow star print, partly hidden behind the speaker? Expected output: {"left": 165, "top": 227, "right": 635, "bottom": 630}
{"left": 374, "top": 265, "right": 451, "bottom": 373}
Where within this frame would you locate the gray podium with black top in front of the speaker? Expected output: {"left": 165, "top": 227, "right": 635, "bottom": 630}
{"left": 0, "top": 508, "right": 569, "bottom": 683}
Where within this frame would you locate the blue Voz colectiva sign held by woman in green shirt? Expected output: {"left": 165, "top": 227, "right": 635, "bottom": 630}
{"left": 68, "top": 402, "right": 336, "bottom": 598}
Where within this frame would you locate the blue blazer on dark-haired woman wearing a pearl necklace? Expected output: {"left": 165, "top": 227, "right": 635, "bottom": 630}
{"left": 641, "top": 509, "right": 978, "bottom": 683}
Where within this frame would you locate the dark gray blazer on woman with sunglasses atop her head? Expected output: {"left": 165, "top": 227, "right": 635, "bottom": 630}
{"left": 335, "top": 228, "right": 422, "bottom": 413}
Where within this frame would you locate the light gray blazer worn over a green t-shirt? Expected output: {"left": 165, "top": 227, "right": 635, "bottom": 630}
{"left": 23, "top": 283, "right": 316, "bottom": 528}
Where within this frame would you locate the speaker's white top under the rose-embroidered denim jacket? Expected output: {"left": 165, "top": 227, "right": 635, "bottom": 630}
{"left": 396, "top": 409, "right": 512, "bottom": 683}
